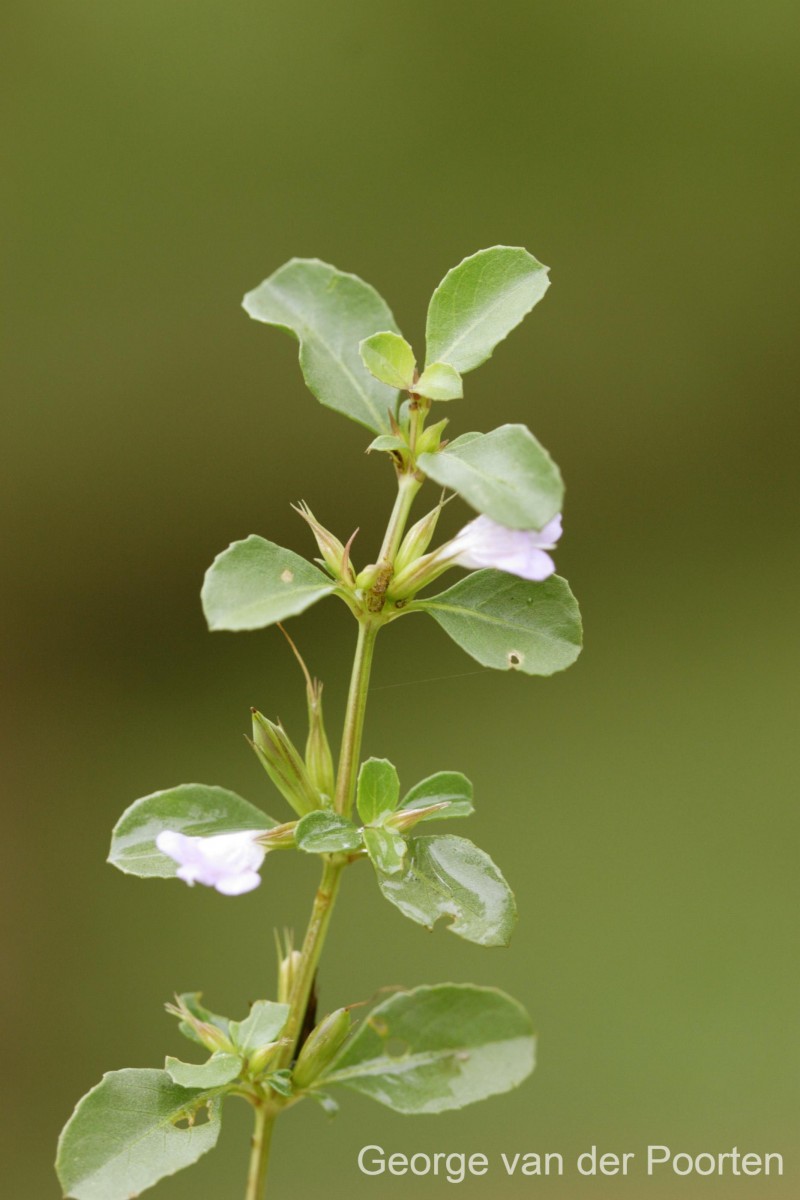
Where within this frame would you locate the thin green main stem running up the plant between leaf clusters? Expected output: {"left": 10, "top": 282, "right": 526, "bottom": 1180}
{"left": 245, "top": 475, "right": 420, "bottom": 1200}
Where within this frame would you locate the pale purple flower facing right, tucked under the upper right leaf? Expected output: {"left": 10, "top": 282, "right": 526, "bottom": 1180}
{"left": 446, "top": 512, "right": 561, "bottom": 582}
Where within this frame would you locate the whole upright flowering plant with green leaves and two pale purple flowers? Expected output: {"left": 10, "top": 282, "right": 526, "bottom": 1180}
{"left": 56, "top": 246, "right": 581, "bottom": 1200}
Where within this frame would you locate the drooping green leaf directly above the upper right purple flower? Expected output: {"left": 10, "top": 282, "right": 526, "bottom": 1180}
{"left": 417, "top": 425, "right": 564, "bottom": 529}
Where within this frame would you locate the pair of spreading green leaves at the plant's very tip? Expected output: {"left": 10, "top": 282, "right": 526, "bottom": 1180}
{"left": 243, "top": 246, "right": 548, "bottom": 433}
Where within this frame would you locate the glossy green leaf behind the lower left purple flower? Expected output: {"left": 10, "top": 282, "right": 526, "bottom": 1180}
{"left": 108, "top": 784, "right": 277, "bottom": 880}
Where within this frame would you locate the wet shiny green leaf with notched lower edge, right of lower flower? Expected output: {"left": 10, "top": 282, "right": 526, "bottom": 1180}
{"left": 378, "top": 834, "right": 517, "bottom": 946}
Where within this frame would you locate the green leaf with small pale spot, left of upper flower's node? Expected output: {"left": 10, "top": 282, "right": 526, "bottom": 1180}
{"left": 200, "top": 534, "right": 336, "bottom": 631}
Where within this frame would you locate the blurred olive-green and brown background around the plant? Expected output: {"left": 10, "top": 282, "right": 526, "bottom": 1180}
{"left": 0, "top": 0, "right": 800, "bottom": 1200}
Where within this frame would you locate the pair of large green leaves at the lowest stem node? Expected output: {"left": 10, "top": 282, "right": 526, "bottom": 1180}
{"left": 56, "top": 984, "right": 535, "bottom": 1200}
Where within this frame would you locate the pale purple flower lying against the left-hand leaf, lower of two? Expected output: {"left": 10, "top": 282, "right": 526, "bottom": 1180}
{"left": 156, "top": 829, "right": 266, "bottom": 896}
